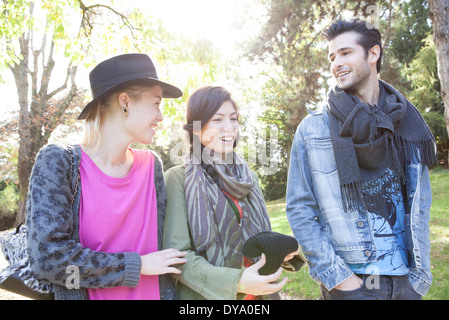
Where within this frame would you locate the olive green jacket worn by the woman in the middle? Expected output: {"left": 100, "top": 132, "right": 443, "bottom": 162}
{"left": 163, "top": 165, "right": 260, "bottom": 300}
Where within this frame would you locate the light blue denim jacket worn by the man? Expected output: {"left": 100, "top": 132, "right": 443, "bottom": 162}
{"left": 286, "top": 110, "right": 432, "bottom": 295}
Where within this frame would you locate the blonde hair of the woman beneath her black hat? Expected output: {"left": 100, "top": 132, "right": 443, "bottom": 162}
{"left": 81, "top": 85, "right": 153, "bottom": 152}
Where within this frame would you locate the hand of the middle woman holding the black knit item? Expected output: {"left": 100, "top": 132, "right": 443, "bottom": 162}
{"left": 238, "top": 254, "right": 287, "bottom": 296}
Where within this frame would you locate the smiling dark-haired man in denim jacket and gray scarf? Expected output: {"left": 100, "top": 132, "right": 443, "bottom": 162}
{"left": 286, "top": 19, "right": 437, "bottom": 299}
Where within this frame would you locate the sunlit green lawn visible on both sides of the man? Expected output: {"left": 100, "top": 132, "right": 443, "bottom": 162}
{"left": 267, "top": 167, "right": 449, "bottom": 300}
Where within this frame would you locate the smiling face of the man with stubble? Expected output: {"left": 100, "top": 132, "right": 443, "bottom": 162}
{"left": 329, "top": 32, "right": 377, "bottom": 93}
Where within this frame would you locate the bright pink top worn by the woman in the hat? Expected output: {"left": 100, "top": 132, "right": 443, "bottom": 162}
{"left": 79, "top": 149, "right": 160, "bottom": 300}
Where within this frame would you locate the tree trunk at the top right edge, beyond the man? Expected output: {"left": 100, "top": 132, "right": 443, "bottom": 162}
{"left": 429, "top": 0, "right": 449, "bottom": 161}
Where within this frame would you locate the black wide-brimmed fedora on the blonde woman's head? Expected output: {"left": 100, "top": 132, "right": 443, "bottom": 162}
{"left": 78, "top": 53, "right": 182, "bottom": 120}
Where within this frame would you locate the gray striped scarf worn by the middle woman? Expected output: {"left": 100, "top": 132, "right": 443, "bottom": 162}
{"left": 185, "top": 148, "right": 271, "bottom": 267}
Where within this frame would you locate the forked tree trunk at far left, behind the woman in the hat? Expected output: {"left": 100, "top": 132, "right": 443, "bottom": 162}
{"left": 11, "top": 32, "right": 78, "bottom": 225}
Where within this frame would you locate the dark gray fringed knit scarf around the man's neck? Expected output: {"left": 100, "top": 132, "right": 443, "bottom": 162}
{"left": 328, "top": 80, "right": 437, "bottom": 211}
